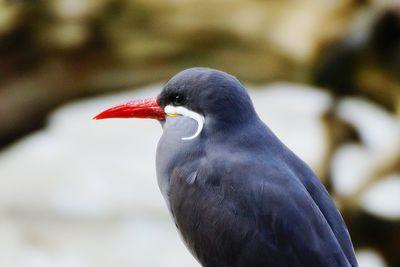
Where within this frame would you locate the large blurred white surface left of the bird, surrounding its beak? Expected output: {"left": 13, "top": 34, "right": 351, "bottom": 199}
{"left": 0, "top": 87, "right": 199, "bottom": 267}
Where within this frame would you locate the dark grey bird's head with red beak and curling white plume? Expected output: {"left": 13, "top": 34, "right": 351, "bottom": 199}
{"left": 94, "top": 68, "right": 255, "bottom": 139}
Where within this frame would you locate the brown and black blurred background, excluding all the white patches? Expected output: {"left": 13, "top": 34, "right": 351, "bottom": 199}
{"left": 0, "top": 0, "right": 400, "bottom": 267}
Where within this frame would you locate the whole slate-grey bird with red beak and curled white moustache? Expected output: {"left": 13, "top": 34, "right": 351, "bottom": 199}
{"left": 94, "top": 67, "right": 358, "bottom": 267}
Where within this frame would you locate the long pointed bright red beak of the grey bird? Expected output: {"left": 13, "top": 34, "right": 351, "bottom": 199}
{"left": 93, "top": 97, "right": 165, "bottom": 121}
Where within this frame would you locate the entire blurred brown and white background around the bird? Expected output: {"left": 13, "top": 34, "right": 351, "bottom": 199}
{"left": 0, "top": 0, "right": 400, "bottom": 267}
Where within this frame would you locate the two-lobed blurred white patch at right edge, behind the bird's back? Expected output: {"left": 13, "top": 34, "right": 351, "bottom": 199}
{"left": 331, "top": 98, "right": 400, "bottom": 199}
